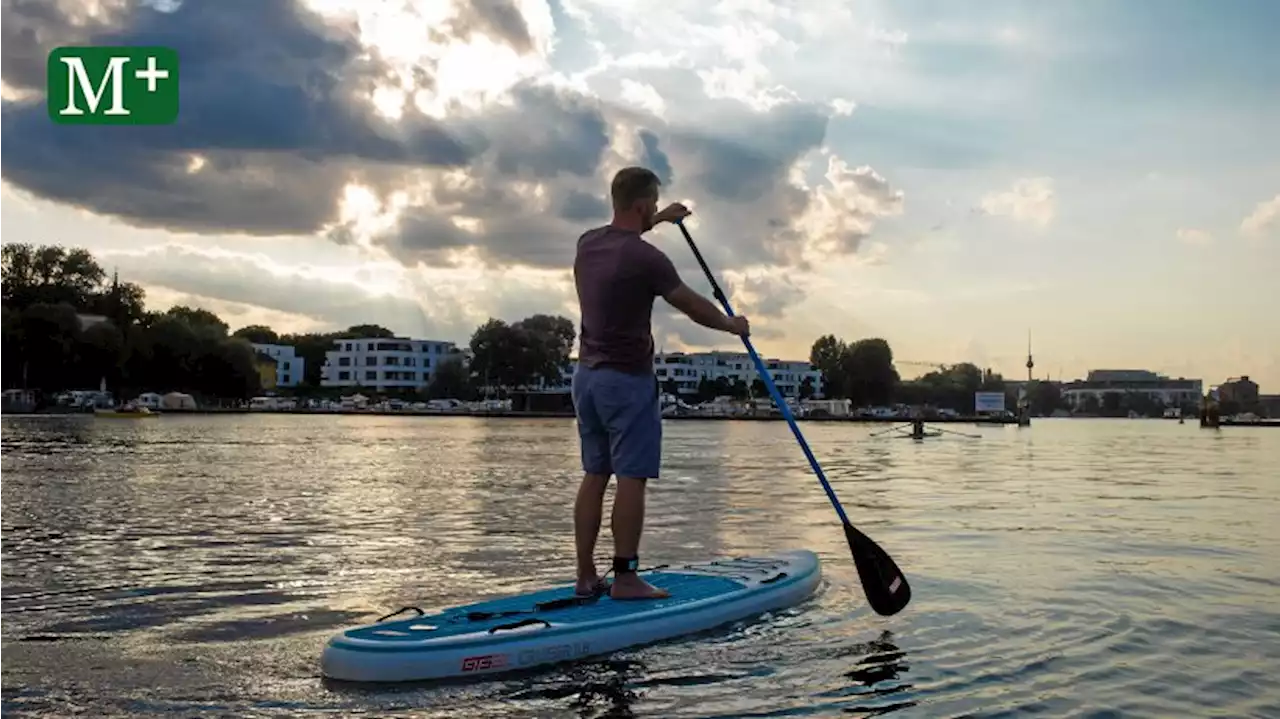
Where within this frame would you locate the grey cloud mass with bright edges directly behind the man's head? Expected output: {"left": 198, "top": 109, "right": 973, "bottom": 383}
{"left": 379, "top": 97, "right": 826, "bottom": 271}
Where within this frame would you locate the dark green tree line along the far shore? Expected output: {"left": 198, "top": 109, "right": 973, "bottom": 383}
{"left": 0, "top": 243, "right": 1062, "bottom": 421}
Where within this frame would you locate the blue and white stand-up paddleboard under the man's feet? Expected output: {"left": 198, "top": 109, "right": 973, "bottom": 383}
{"left": 320, "top": 550, "right": 822, "bottom": 682}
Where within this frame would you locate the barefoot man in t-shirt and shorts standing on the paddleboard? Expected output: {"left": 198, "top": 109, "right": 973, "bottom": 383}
{"left": 573, "top": 168, "right": 750, "bottom": 599}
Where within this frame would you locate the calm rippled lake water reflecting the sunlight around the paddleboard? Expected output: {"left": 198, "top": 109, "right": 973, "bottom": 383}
{"left": 0, "top": 415, "right": 1280, "bottom": 718}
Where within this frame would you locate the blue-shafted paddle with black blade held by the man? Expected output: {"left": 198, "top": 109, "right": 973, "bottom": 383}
{"left": 676, "top": 220, "right": 911, "bottom": 615}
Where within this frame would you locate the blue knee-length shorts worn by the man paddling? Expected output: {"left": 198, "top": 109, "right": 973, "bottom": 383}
{"left": 573, "top": 366, "right": 662, "bottom": 480}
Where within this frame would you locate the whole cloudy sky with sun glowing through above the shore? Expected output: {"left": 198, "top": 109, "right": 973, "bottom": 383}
{"left": 0, "top": 0, "right": 1280, "bottom": 391}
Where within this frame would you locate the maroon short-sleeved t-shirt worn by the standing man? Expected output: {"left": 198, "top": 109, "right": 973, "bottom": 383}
{"left": 573, "top": 225, "right": 680, "bottom": 375}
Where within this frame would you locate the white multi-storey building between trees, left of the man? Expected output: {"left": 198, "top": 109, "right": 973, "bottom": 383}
{"left": 320, "top": 338, "right": 456, "bottom": 391}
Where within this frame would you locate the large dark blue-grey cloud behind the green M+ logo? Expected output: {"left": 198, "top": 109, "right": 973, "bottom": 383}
{"left": 0, "top": 0, "right": 485, "bottom": 233}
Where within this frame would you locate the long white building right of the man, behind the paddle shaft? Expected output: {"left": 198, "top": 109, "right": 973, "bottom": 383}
{"left": 654, "top": 352, "right": 822, "bottom": 398}
